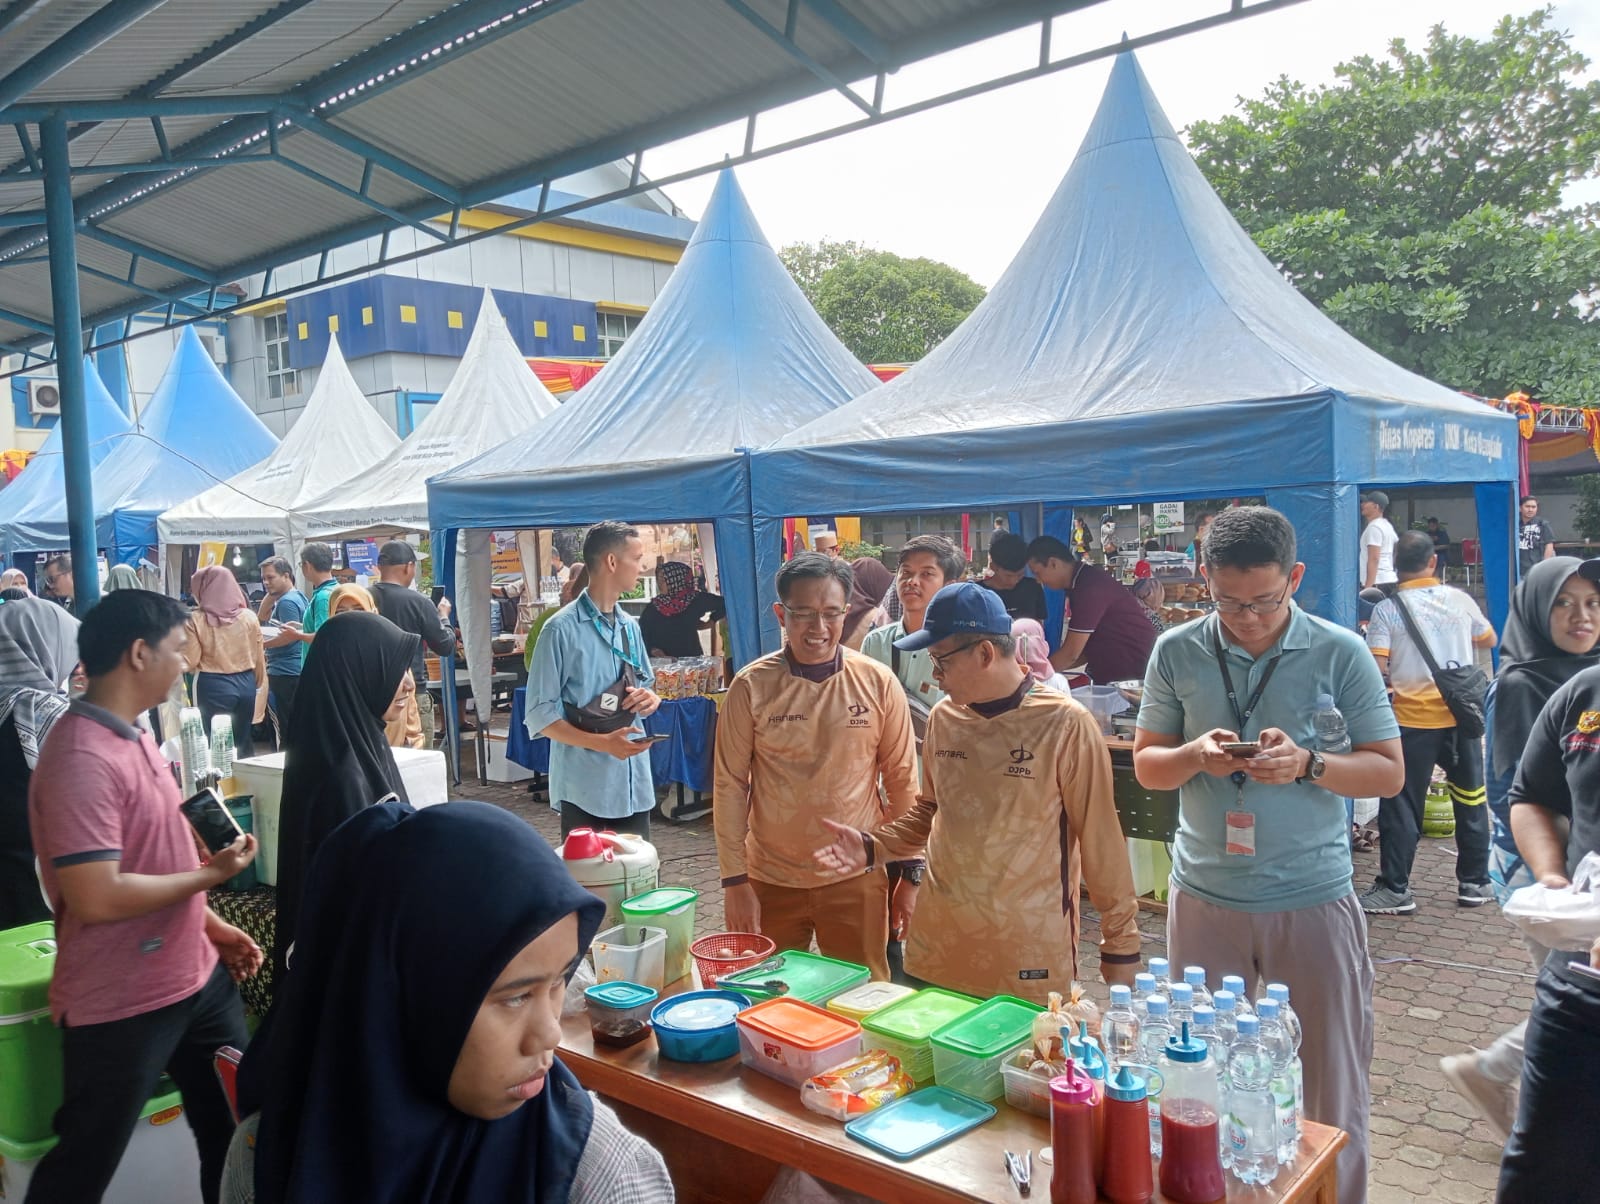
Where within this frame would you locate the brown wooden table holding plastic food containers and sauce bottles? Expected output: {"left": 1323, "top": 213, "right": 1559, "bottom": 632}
{"left": 560, "top": 1005, "right": 1349, "bottom": 1204}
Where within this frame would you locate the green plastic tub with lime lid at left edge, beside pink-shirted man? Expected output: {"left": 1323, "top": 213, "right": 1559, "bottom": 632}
{"left": 0, "top": 921, "right": 61, "bottom": 1143}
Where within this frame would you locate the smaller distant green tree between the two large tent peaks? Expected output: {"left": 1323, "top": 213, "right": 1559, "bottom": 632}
{"left": 778, "top": 242, "right": 984, "bottom": 363}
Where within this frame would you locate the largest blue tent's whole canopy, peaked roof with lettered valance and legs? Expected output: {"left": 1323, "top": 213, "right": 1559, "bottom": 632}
{"left": 750, "top": 51, "right": 1517, "bottom": 647}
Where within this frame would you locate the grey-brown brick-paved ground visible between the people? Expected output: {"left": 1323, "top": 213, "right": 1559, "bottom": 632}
{"left": 461, "top": 785, "right": 1533, "bottom": 1204}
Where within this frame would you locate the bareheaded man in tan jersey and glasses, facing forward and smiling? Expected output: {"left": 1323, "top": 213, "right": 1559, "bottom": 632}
{"left": 712, "top": 552, "right": 915, "bottom": 978}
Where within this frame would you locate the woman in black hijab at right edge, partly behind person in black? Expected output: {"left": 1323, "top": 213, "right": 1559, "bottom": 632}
{"left": 1440, "top": 556, "right": 1600, "bottom": 1142}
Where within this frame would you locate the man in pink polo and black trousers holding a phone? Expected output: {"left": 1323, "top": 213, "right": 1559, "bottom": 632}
{"left": 27, "top": 589, "right": 261, "bottom": 1204}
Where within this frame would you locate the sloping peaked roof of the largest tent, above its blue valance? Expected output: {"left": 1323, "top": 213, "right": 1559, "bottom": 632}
{"left": 776, "top": 50, "right": 1482, "bottom": 447}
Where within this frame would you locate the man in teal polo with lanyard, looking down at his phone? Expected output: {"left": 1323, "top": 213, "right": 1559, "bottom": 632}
{"left": 1133, "top": 506, "right": 1405, "bottom": 1204}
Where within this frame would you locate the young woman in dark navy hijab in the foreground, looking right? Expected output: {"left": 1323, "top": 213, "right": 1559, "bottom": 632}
{"left": 222, "top": 800, "right": 672, "bottom": 1204}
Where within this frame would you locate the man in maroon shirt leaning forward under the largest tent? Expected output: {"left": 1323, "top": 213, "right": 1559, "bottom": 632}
{"left": 1027, "top": 535, "right": 1155, "bottom": 684}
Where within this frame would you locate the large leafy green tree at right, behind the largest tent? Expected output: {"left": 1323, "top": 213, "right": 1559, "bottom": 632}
{"left": 1187, "top": 8, "right": 1600, "bottom": 405}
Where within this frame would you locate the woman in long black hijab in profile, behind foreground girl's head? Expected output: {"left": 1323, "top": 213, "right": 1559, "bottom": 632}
{"left": 272, "top": 612, "right": 419, "bottom": 983}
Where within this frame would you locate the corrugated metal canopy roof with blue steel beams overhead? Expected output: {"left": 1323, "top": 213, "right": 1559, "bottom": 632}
{"left": 0, "top": 0, "right": 1299, "bottom": 362}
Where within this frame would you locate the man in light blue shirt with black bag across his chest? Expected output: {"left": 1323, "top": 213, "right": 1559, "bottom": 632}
{"left": 523, "top": 522, "right": 661, "bottom": 839}
